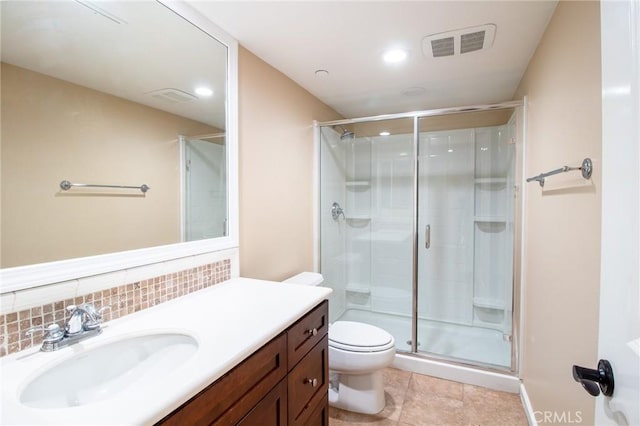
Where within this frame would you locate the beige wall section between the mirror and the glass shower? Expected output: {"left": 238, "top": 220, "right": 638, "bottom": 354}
{"left": 238, "top": 47, "right": 340, "bottom": 280}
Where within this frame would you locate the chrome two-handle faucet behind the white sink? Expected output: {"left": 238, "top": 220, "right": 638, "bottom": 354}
{"left": 26, "top": 303, "right": 110, "bottom": 352}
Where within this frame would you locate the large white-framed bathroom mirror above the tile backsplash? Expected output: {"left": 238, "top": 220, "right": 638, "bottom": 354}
{"left": 0, "top": 0, "right": 237, "bottom": 293}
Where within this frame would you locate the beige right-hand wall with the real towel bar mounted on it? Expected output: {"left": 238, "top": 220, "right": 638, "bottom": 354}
{"left": 516, "top": 2, "right": 602, "bottom": 424}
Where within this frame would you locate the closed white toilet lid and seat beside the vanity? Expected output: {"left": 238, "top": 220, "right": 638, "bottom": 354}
{"left": 329, "top": 321, "right": 395, "bottom": 352}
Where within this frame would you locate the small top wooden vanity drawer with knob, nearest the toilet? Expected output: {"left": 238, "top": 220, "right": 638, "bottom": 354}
{"left": 287, "top": 300, "right": 329, "bottom": 370}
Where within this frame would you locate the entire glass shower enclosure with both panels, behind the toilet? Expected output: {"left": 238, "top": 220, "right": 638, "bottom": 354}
{"left": 319, "top": 103, "right": 520, "bottom": 371}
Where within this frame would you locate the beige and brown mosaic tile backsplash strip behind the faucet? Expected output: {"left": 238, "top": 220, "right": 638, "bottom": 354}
{"left": 0, "top": 259, "right": 231, "bottom": 356}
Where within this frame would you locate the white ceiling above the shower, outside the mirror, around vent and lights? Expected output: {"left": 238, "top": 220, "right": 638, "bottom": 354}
{"left": 189, "top": 0, "right": 557, "bottom": 118}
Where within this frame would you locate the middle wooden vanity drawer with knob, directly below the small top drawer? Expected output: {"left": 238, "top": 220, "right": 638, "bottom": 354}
{"left": 287, "top": 334, "right": 329, "bottom": 425}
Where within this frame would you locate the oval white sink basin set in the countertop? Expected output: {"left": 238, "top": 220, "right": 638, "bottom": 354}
{"left": 18, "top": 333, "right": 198, "bottom": 409}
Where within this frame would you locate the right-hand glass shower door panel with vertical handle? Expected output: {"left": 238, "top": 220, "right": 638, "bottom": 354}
{"left": 417, "top": 115, "right": 515, "bottom": 368}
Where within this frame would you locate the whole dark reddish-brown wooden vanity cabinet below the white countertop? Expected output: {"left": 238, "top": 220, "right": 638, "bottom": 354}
{"left": 157, "top": 300, "right": 329, "bottom": 426}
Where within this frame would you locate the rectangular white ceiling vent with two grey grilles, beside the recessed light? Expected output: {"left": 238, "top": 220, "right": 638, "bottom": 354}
{"left": 422, "top": 24, "right": 496, "bottom": 58}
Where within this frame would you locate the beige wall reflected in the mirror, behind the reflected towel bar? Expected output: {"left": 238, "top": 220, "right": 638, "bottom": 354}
{"left": 1, "top": 64, "right": 218, "bottom": 267}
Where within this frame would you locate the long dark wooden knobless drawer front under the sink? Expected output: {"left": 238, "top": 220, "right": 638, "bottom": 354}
{"left": 158, "top": 333, "right": 287, "bottom": 426}
